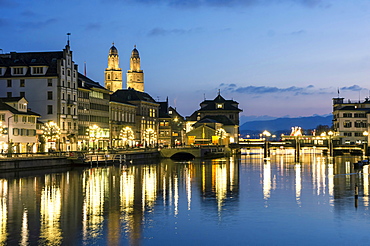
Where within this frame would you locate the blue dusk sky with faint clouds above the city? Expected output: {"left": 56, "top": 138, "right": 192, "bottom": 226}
{"left": 0, "top": 0, "right": 370, "bottom": 118}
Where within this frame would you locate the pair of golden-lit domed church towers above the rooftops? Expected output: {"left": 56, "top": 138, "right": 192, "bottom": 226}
{"left": 104, "top": 43, "right": 144, "bottom": 92}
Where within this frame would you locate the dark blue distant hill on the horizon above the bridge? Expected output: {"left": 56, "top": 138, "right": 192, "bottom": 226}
{"left": 240, "top": 115, "right": 333, "bottom": 133}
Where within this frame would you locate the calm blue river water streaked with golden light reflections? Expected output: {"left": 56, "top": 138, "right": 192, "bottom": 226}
{"left": 0, "top": 155, "right": 370, "bottom": 245}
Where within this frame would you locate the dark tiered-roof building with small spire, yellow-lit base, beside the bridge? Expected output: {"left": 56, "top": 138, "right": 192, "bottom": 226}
{"left": 186, "top": 93, "right": 242, "bottom": 144}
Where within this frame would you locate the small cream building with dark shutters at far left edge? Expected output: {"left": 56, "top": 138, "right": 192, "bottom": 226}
{"left": 0, "top": 97, "right": 40, "bottom": 153}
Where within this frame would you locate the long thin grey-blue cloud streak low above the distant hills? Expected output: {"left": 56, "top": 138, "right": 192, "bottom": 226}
{"left": 220, "top": 83, "right": 367, "bottom": 96}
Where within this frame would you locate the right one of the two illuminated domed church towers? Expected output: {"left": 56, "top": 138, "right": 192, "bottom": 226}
{"left": 127, "top": 45, "right": 144, "bottom": 92}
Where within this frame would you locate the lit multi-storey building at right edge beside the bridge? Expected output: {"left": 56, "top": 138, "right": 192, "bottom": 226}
{"left": 333, "top": 97, "right": 370, "bottom": 144}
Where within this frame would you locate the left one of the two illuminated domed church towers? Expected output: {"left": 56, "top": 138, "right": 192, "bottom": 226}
{"left": 105, "top": 43, "right": 122, "bottom": 91}
